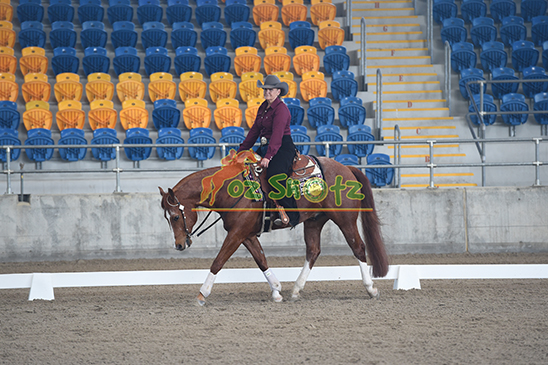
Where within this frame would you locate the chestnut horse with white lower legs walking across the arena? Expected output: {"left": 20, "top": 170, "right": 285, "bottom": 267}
{"left": 159, "top": 154, "right": 388, "bottom": 305}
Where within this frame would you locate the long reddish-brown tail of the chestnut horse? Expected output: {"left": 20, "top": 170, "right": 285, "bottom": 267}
{"left": 348, "top": 166, "right": 388, "bottom": 277}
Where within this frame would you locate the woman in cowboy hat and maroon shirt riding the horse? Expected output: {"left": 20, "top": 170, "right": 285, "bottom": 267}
{"left": 238, "top": 75, "right": 300, "bottom": 227}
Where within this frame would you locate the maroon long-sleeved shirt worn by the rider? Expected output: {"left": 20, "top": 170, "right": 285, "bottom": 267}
{"left": 238, "top": 98, "right": 291, "bottom": 160}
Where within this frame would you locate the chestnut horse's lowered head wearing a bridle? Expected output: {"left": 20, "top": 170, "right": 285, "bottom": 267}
{"left": 158, "top": 187, "right": 198, "bottom": 251}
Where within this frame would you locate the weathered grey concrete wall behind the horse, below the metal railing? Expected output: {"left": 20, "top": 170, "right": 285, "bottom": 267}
{"left": 0, "top": 187, "right": 548, "bottom": 261}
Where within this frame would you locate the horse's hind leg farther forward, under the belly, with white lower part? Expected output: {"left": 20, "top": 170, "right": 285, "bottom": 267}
{"left": 291, "top": 216, "right": 328, "bottom": 300}
